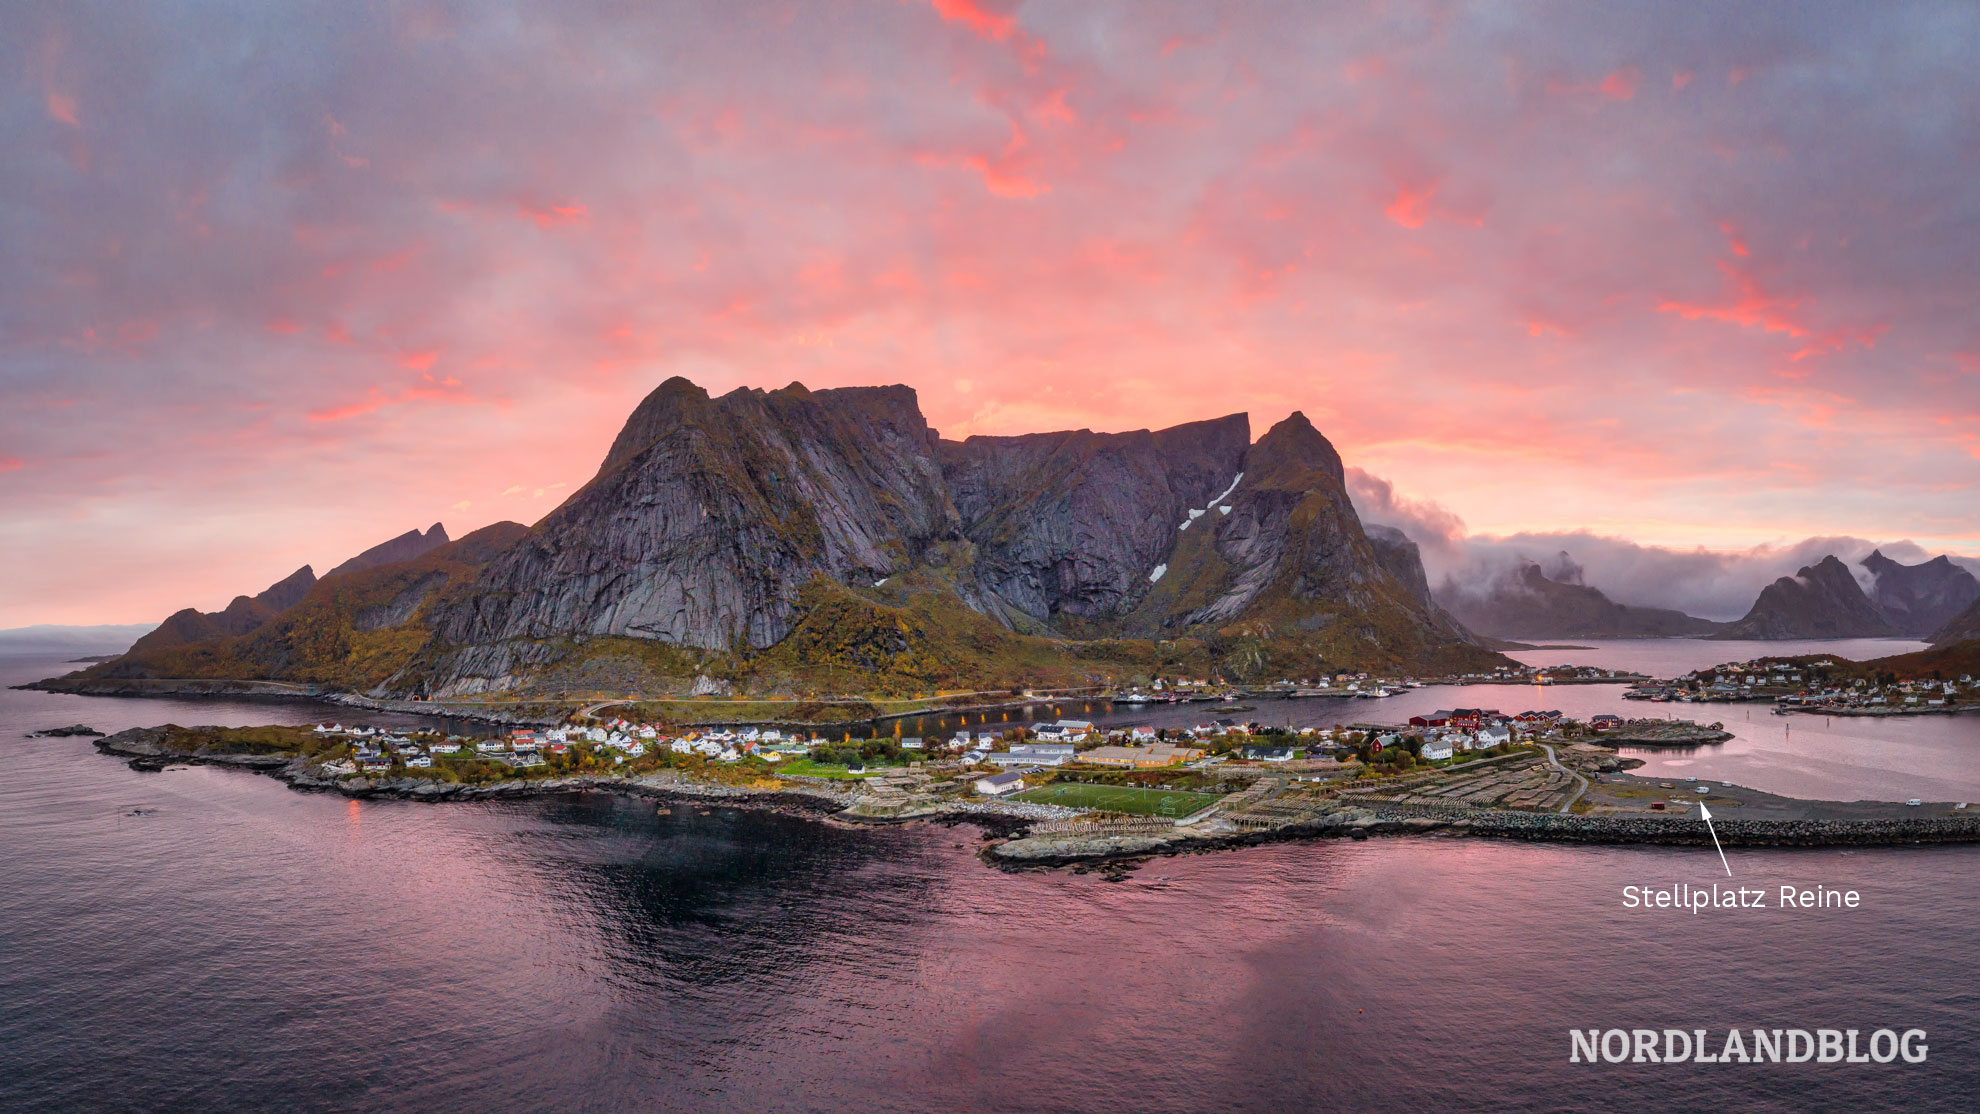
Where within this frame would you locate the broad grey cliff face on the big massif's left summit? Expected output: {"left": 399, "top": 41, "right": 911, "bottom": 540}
{"left": 438, "top": 378, "right": 960, "bottom": 649}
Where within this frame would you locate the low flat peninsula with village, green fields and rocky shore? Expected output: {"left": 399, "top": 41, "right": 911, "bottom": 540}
{"left": 81, "top": 704, "right": 1980, "bottom": 869}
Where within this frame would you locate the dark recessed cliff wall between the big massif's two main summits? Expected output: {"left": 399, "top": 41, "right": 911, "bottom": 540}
{"left": 939, "top": 414, "right": 1251, "bottom": 623}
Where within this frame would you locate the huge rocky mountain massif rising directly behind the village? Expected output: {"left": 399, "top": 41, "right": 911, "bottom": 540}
{"left": 38, "top": 378, "right": 1505, "bottom": 696}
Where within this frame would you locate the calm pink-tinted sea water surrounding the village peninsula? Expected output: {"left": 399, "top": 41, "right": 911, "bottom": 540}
{"left": 0, "top": 659, "right": 1980, "bottom": 1112}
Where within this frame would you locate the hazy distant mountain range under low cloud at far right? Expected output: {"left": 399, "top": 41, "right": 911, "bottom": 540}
{"left": 1437, "top": 550, "right": 1980, "bottom": 641}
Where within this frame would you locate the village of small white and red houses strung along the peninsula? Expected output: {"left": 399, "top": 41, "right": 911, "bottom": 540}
{"left": 287, "top": 696, "right": 1710, "bottom": 833}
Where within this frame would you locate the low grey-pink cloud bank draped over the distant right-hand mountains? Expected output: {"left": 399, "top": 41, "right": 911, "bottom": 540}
{"left": 1346, "top": 467, "right": 1980, "bottom": 621}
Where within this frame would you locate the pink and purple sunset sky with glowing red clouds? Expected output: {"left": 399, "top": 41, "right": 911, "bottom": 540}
{"left": 0, "top": 0, "right": 1980, "bottom": 625}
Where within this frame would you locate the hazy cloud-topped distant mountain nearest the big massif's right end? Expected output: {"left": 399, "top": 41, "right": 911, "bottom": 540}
{"left": 1437, "top": 554, "right": 1721, "bottom": 639}
